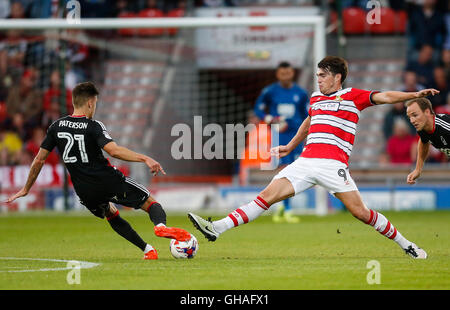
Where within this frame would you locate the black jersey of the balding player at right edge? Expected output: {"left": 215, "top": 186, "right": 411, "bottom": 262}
{"left": 417, "top": 114, "right": 450, "bottom": 157}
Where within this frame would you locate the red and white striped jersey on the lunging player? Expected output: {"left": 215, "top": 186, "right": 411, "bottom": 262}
{"left": 300, "top": 88, "right": 374, "bottom": 165}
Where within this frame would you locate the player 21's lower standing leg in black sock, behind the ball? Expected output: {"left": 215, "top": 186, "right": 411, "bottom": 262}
{"left": 105, "top": 203, "right": 158, "bottom": 259}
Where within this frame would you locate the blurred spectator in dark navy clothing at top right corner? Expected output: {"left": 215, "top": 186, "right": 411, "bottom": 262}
{"left": 409, "top": 0, "right": 446, "bottom": 59}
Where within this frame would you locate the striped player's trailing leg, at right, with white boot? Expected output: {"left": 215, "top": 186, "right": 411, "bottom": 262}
{"left": 335, "top": 191, "right": 427, "bottom": 259}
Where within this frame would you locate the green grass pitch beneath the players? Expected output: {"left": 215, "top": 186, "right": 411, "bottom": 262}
{"left": 0, "top": 211, "right": 450, "bottom": 290}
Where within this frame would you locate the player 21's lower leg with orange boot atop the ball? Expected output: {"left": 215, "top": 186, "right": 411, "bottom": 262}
{"left": 141, "top": 196, "right": 191, "bottom": 241}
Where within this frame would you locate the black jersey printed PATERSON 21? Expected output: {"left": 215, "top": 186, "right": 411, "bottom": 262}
{"left": 41, "top": 115, "right": 124, "bottom": 185}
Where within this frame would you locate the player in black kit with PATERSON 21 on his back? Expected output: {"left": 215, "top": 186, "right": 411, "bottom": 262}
{"left": 6, "top": 82, "right": 191, "bottom": 259}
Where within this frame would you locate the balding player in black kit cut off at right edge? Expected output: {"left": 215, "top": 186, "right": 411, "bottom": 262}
{"left": 406, "top": 98, "right": 450, "bottom": 184}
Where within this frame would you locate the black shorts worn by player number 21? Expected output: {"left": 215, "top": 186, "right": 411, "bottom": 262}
{"left": 74, "top": 177, "right": 150, "bottom": 218}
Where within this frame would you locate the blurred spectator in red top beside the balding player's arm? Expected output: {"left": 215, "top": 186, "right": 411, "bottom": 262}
{"left": 380, "top": 119, "right": 417, "bottom": 164}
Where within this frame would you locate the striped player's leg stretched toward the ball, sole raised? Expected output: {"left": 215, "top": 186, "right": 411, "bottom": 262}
{"left": 188, "top": 178, "right": 295, "bottom": 241}
